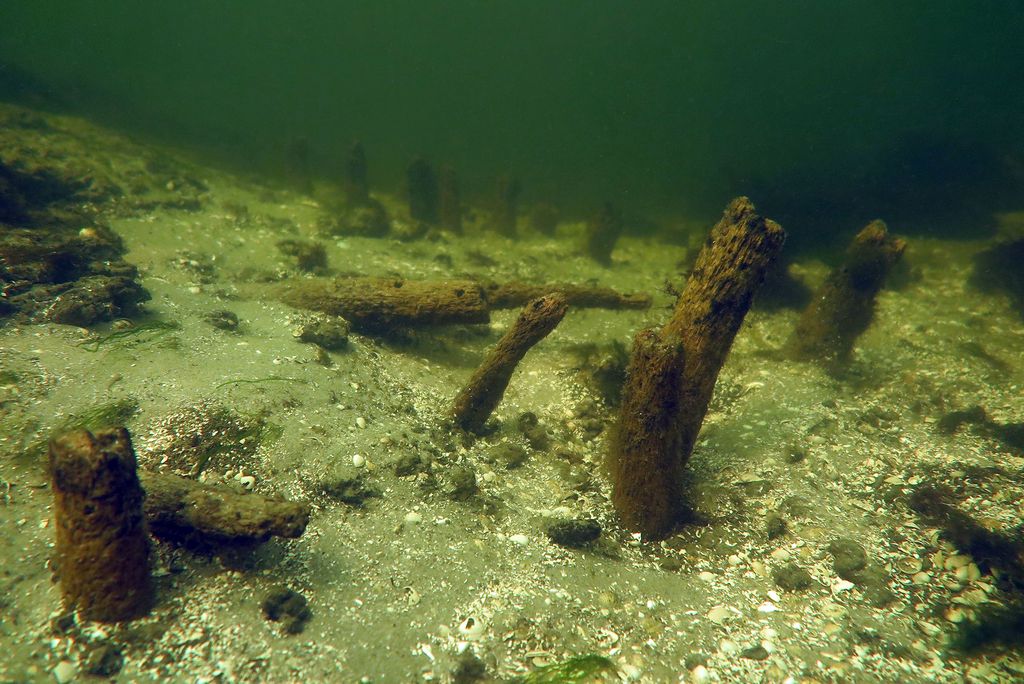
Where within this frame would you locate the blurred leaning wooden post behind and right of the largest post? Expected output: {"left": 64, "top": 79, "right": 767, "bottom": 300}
{"left": 786, "top": 220, "right": 906, "bottom": 365}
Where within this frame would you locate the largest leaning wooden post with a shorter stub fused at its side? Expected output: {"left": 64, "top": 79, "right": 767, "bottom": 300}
{"left": 608, "top": 198, "right": 785, "bottom": 540}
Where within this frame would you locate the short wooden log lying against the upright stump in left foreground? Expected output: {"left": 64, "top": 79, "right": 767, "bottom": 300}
{"left": 139, "top": 471, "right": 309, "bottom": 546}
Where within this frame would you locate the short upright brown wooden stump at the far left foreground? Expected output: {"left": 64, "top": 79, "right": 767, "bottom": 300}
{"left": 49, "top": 428, "right": 154, "bottom": 622}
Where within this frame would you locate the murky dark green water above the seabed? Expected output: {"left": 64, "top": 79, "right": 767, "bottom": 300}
{"left": 0, "top": 0, "right": 1024, "bottom": 246}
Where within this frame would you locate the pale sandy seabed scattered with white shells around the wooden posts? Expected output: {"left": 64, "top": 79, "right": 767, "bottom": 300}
{"left": 0, "top": 105, "right": 1024, "bottom": 682}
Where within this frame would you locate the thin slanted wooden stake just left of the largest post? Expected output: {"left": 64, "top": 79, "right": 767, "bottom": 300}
{"left": 452, "top": 293, "right": 568, "bottom": 432}
